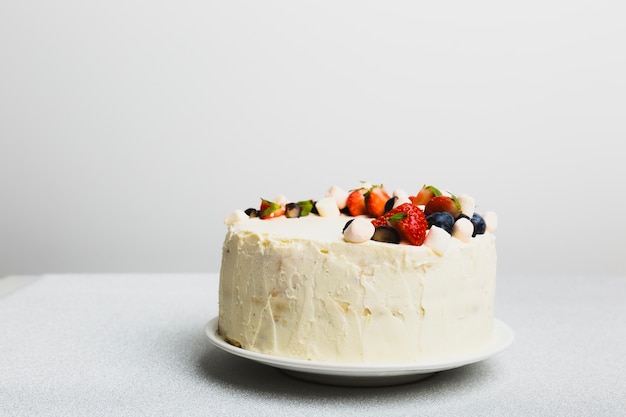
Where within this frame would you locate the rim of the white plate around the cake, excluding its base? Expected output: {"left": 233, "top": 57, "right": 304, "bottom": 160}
{"left": 204, "top": 316, "right": 515, "bottom": 377}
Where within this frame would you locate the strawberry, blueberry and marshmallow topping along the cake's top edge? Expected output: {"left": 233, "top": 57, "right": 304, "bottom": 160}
{"left": 225, "top": 182, "right": 497, "bottom": 255}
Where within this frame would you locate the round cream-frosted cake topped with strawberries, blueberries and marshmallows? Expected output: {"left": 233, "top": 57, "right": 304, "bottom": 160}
{"left": 218, "top": 183, "right": 497, "bottom": 363}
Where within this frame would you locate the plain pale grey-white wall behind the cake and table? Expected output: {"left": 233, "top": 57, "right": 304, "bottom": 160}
{"left": 0, "top": 0, "right": 626, "bottom": 276}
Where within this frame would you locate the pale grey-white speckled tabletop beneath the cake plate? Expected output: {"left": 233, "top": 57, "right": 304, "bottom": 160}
{"left": 0, "top": 273, "right": 626, "bottom": 417}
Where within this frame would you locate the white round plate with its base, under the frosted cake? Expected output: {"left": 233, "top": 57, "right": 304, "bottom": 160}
{"left": 204, "top": 317, "right": 514, "bottom": 386}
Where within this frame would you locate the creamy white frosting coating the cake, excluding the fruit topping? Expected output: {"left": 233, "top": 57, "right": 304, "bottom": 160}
{"left": 219, "top": 215, "right": 496, "bottom": 362}
